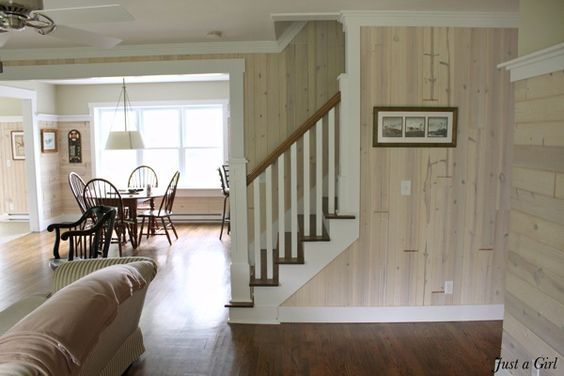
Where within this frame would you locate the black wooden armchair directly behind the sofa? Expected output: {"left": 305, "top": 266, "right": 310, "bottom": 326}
{"left": 47, "top": 206, "right": 116, "bottom": 268}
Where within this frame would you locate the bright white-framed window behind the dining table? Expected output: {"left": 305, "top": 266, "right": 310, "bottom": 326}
{"left": 94, "top": 101, "right": 227, "bottom": 189}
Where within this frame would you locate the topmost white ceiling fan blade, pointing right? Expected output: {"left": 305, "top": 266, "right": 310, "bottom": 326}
{"left": 39, "top": 4, "right": 135, "bottom": 25}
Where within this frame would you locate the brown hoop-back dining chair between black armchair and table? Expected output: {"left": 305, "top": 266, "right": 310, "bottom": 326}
{"left": 83, "top": 178, "right": 137, "bottom": 257}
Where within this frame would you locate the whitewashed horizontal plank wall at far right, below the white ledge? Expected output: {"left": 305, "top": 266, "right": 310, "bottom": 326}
{"left": 502, "top": 71, "right": 564, "bottom": 375}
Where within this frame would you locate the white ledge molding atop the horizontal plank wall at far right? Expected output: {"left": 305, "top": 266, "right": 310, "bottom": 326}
{"left": 497, "top": 43, "right": 564, "bottom": 82}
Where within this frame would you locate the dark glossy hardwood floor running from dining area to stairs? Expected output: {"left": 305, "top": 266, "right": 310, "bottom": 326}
{"left": 0, "top": 225, "right": 501, "bottom": 376}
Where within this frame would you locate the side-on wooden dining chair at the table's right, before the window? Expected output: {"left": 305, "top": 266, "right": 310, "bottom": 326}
{"left": 138, "top": 171, "right": 180, "bottom": 245}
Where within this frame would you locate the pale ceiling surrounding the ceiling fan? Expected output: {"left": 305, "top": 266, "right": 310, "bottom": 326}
{"left": 0, "top": 0, "right": 518, "bottom": 49}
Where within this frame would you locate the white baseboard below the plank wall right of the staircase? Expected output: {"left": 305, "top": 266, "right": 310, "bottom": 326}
{"left": 278, "top": 304, "right": 503, "bottom": 323}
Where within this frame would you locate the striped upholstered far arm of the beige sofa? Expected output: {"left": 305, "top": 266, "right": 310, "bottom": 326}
{"left": 51, "top": 257, "right": 157, "bottom": 293}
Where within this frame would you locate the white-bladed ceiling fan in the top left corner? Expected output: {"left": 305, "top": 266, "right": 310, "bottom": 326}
{"left": 0, "top": 0, "right": 133, "bottom": 48}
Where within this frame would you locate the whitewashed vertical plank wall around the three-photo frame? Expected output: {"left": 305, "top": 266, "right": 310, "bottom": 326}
{"left": 285, "top": 27, "right": 517, "bottom": 306}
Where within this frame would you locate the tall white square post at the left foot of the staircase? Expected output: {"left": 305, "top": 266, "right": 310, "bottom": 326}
{"left": 229, "top": 72, "right": 252, "bottom": 305}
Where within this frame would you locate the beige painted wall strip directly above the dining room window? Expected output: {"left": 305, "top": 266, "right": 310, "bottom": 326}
{"left": 55, "top": 81, "right": 229, "bottom": 115}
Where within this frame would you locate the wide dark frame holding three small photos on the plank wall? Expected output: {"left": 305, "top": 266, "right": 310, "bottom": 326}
{"left": 372, "top": 107, "right": 458, "bottom": 148}
